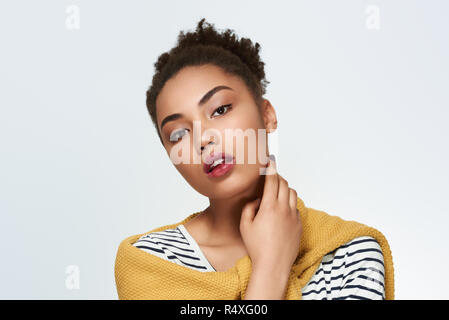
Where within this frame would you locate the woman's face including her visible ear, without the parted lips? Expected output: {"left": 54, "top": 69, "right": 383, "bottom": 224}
{"left": 156, "top": 64, "right": 277, "bottom": 199}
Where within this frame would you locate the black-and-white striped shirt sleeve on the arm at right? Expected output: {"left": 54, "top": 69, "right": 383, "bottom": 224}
{"left": 336, "top": 236, "right": 385, "bottom": 300}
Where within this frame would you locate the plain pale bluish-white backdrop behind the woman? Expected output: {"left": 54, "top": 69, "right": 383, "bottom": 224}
{"left": 0, "top": 0, "right": 449, "bottom": 299}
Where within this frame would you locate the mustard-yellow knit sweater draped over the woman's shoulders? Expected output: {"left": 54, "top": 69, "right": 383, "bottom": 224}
{"left": 115, "top": 197, "right": 394, "bottom": 300}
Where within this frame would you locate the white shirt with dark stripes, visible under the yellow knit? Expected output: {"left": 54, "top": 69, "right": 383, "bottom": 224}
{"left": 133, "top": 224, "right": 385, "bottom": 300}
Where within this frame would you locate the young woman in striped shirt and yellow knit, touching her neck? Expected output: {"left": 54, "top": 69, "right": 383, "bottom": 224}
{"left": 115, "top": 19, "right": 394, "bottom": 299}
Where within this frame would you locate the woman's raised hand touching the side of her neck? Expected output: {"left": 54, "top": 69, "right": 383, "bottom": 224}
{"left": 240, "top": 159, "right": 302, "bottom": 273}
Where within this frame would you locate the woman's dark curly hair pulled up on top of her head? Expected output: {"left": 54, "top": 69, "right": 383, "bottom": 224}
{"left": 146, "top": 18, "right": 270, "bottom": 144}
